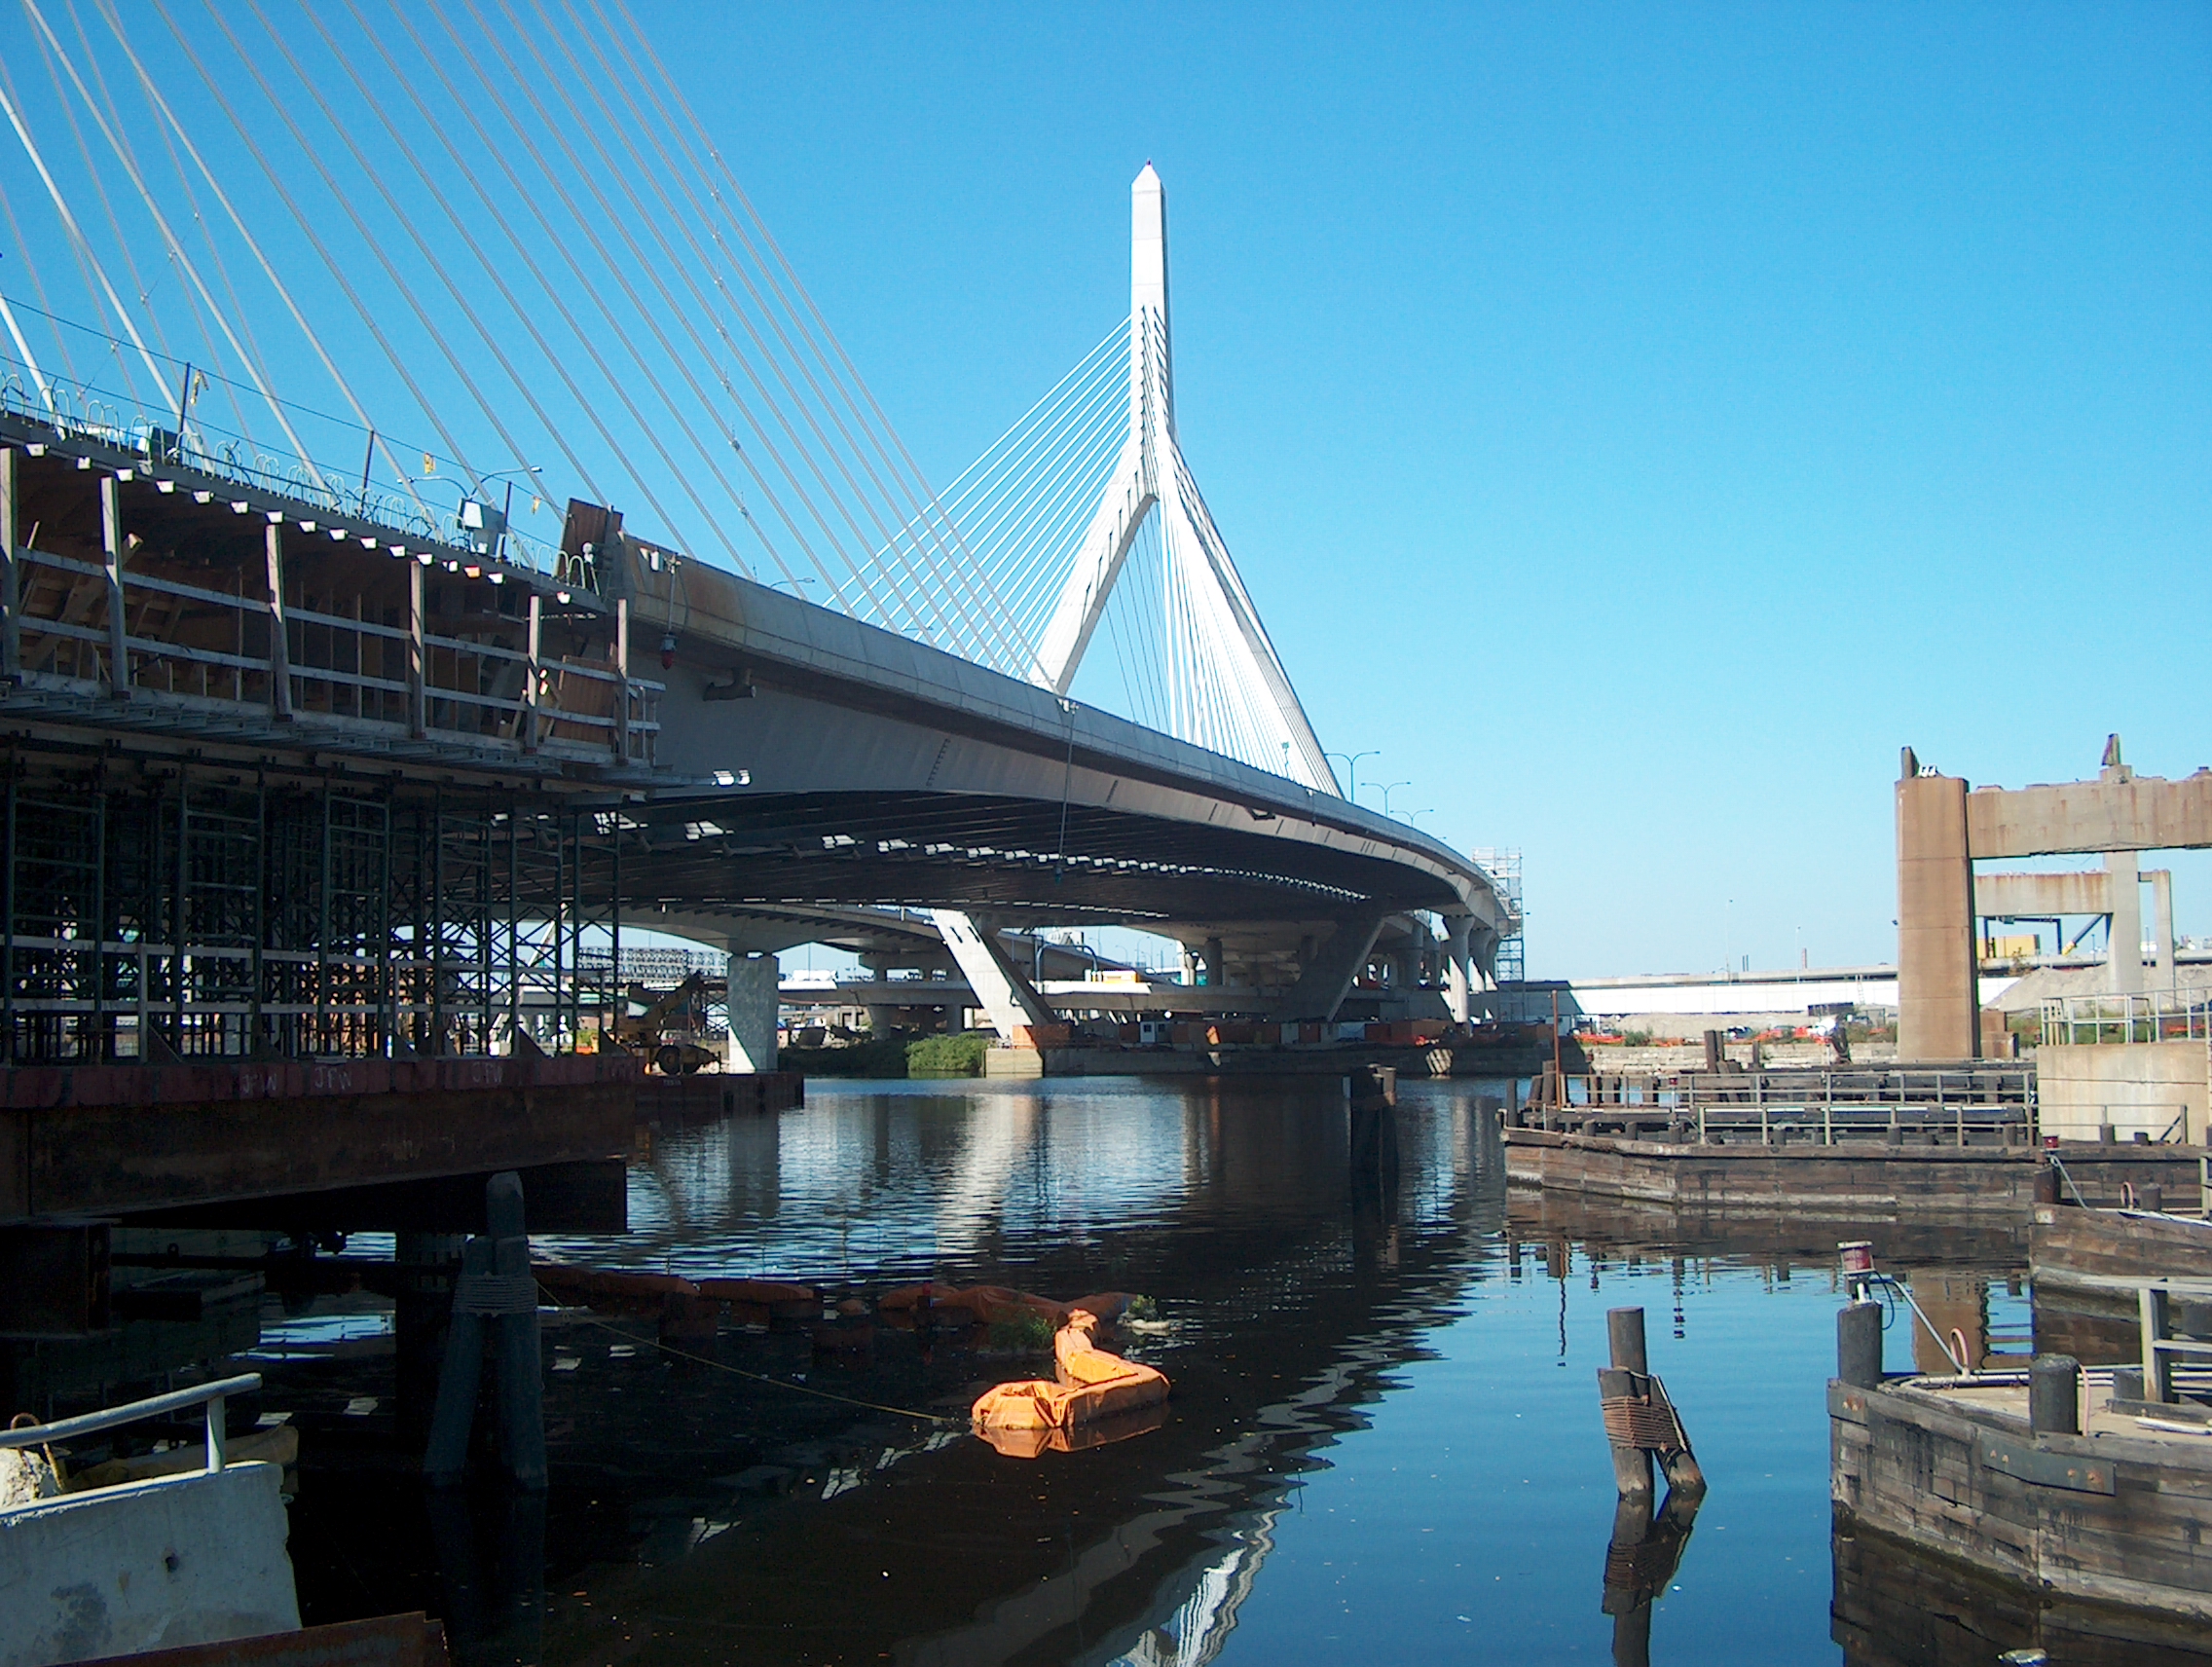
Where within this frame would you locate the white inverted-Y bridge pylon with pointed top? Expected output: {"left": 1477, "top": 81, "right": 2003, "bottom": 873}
{"left": 1031, "top": 164, "right": 1339, "bottom": 794}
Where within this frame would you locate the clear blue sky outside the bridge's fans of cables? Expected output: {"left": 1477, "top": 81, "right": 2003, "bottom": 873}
{"left": 0, "top": 0, "right": 2212, "bottom": 975}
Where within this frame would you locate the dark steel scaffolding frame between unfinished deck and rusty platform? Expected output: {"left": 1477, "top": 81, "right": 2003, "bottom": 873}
{"left": 0, "top": 750, "right": 621, "bottom": 1063}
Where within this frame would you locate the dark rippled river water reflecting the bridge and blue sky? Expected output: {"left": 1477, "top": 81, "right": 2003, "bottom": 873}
{"left": 272, "top": 1079, "right": 2033, "bottom": 1667}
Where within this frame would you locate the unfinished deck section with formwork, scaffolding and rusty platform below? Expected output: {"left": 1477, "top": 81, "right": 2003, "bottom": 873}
{"left": 0, "top": 411, "right": 664, "bottom": 1273}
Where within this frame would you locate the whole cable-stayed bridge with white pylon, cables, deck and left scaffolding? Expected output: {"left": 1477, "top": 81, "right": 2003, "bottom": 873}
{"left": 0, "top": 0, "right": 1518, "bottom": 1079}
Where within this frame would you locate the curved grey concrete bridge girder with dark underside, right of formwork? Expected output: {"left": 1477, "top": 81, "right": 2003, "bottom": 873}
{"left": 624, "top": 539, "right": 1502, "bottom": 922}
